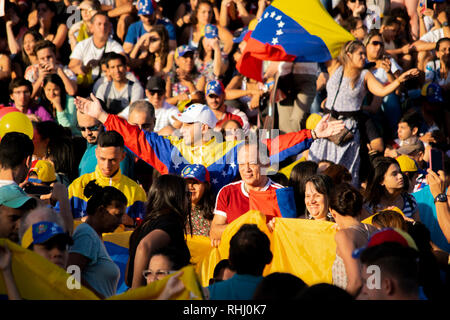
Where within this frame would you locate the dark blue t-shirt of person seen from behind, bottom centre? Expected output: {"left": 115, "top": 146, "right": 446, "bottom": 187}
{"left": 208, "top": 274, "right": 263, "bottom": 300}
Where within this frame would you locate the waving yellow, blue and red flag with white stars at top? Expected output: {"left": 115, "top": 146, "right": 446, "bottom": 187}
{"left": 237, "top": 0, "right": 354, "bottom": 81}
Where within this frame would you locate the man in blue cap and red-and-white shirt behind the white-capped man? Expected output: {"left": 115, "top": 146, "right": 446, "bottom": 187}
{"left": 205, "top": 80, "right": 250, "bottom": 134}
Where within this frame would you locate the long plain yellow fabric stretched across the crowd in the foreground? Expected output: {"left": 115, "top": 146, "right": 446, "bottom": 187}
{"left": 0, "top": 211, "right": 342, "bottom": 300}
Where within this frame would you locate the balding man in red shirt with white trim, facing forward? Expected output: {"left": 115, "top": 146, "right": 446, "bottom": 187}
{"left": 209, "top": 144, "right": 284, "bottom": 246}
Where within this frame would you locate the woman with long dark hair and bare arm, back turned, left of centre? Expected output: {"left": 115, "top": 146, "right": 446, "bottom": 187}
{"left": 125, "top": 174, "right": 192, "bottom": 288}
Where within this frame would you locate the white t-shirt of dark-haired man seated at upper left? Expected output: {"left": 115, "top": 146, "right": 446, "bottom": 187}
{"left": 70, "top": 37, "right": 124, "bottom": 77}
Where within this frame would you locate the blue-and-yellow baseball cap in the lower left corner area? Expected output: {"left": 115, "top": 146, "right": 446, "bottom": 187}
{"left": 21, "top": 221, "right": 72, "bottom": 248}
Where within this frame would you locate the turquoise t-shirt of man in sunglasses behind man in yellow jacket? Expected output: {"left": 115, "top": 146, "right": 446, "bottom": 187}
{"left": 78, "top": 143, "right": 134, "bottom": 179}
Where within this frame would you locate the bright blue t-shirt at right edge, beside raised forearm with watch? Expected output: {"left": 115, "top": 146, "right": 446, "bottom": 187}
{"left": 412, "top": 186, "right": 450, "bottom": 253}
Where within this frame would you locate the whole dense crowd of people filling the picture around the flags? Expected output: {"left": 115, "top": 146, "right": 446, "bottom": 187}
{"left": 0, "top": 0, "right": 450, "bottom": 301}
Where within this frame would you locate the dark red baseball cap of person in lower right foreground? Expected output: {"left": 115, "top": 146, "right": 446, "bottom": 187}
{"left": 352, "top": 228, "right": 418, "bottom": 259}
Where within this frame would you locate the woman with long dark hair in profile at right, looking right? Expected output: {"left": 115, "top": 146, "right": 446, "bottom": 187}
{"left": 364, "top": 157, "right": 419, "bottom": 220}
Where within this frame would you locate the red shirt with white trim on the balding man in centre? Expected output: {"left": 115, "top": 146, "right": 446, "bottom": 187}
{"left": 214, "top": 179, "right": 284, "bottom": 223}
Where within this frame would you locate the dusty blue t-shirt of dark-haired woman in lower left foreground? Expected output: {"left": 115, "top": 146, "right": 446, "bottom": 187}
{"left": 69, "top": 223, "right": 120, "bottom": 297}
